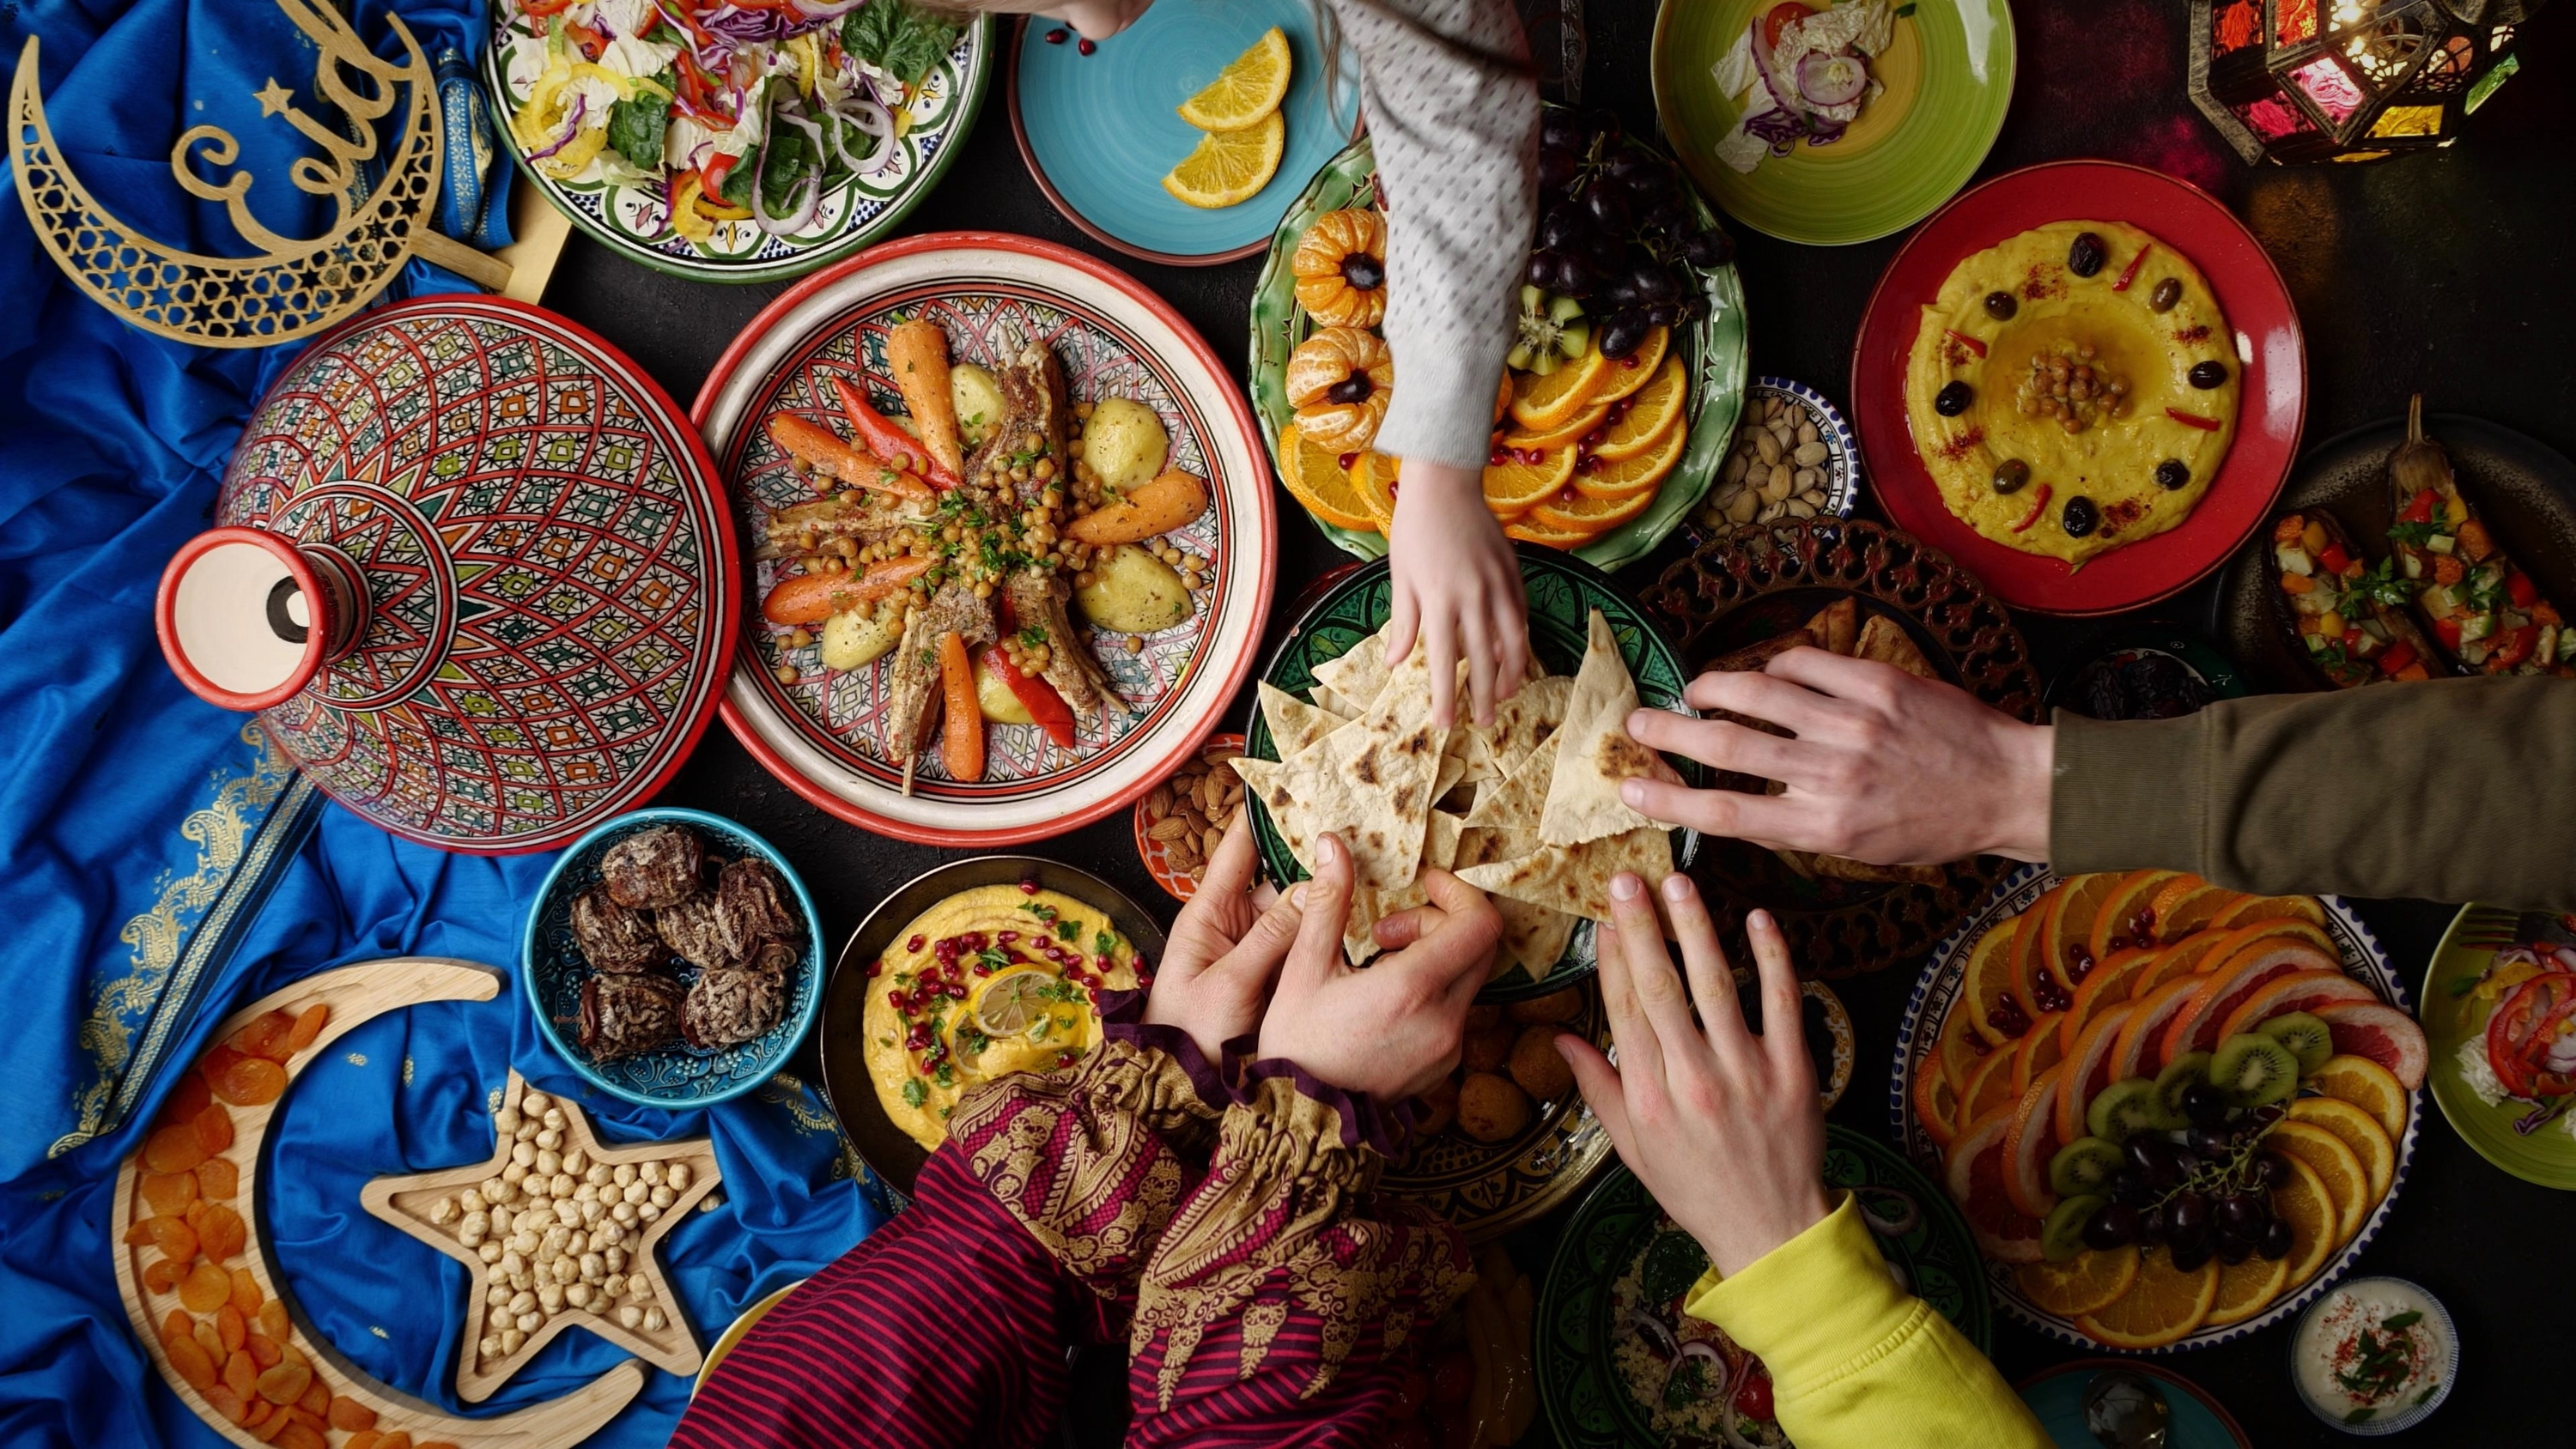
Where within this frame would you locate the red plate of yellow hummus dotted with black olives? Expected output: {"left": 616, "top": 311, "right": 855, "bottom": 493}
{"left": 1852, "top": 162, "right": 2308, "bottom": 615}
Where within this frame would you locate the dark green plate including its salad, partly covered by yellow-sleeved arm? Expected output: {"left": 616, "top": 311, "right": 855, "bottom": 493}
{"left": 1535, "top": 1127, "right": 1994, "bottom": 1449}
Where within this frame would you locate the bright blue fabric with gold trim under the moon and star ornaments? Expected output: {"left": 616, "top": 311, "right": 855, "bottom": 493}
{"left": 0, "top": 0, "right": 876, "bottom": 1449}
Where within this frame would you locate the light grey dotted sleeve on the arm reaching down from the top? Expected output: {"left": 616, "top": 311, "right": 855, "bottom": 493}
{"left": 1329, "top": 0, "right": 1538, "bottom": 469}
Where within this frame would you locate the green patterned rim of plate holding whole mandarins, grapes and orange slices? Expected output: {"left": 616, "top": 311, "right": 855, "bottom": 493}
{"left": 1252, "top": 136, "right": 1747, "bottom": 573}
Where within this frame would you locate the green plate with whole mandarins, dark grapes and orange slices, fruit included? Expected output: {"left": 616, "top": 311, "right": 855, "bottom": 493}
{"left": 1252, "top": 106, "right": 1744, "bottom": 569}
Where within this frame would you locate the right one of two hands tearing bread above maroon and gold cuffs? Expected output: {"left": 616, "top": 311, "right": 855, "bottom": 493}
{"left": 1260, "top": 834, "right": 1502, "bottom": 1101}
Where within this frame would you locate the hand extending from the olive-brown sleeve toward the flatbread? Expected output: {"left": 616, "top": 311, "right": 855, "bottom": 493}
{"left": 1620, "top": 649, "right": 2053, "bottom": 864}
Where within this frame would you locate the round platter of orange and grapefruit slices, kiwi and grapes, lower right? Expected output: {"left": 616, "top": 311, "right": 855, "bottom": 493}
{"left": 1893, "top": 867, "right": 2427, "bottom": 1351}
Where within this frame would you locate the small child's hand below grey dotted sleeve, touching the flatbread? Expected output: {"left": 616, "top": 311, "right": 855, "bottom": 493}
{"left": 1386, "top": 464, "right": 1530, "bottom": 728}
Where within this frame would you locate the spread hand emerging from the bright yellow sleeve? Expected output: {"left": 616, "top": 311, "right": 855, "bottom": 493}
{"left": 1556, "top": 872, "right": 1826, "bottom": 1274}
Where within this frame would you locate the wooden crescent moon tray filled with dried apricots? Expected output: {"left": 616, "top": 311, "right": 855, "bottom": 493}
{"left": 113, "top": 957, "right": 644, "bottom": 1449}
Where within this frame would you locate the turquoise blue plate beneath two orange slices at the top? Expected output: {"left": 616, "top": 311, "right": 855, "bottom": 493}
{"left": 1010, "top": 0, "right": 1360, "bottom": 268}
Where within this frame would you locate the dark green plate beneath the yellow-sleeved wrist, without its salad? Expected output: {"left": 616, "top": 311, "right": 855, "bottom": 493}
{"left": 1533, "top": 1127, "right": 1994, "bottom": 1449}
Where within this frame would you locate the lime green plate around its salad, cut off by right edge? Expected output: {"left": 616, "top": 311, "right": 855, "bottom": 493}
{"left": 2416, "top": 906, "right": 2576, "bottom": 1189}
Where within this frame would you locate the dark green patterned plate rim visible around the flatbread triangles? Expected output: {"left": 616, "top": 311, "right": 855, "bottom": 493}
{"left": 1244, "top": 543, "right": 1708, "bottom": 1001}
